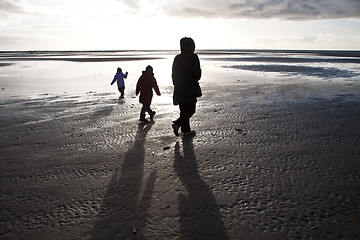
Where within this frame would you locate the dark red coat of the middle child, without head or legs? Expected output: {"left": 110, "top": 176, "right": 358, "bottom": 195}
{"left": 136, "top": 71, "right": 160, "bottom": 105}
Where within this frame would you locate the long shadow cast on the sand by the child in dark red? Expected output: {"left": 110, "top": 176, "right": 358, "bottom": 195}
{"left": 92, "top": 122, "right": 156, "bottom": 240}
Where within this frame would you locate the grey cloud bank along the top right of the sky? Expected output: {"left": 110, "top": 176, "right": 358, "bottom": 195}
{"left": 163, "top": 0, "right": 360, "bottom": 20}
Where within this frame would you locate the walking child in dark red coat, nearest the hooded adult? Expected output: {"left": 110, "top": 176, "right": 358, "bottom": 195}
{"left": 136, "top": 65, "right": 161, "bottom": 122}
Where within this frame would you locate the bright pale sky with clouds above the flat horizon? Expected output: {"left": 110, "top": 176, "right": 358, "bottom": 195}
{"left": 0, "top": 0, "right": 360, "bottom": 51}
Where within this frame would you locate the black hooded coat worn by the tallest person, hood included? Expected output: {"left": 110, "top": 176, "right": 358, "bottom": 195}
{"left": 172, "top": 38, "right": 201, "bottom": 103}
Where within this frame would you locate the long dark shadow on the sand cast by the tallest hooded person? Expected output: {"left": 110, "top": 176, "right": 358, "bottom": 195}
{"left": 174, "top": 138, "right": 228, "bottom": 240}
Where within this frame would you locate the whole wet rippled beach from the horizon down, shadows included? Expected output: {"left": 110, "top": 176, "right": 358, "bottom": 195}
{"left": 0, "top": 51, "right": 360, "bottom": 239}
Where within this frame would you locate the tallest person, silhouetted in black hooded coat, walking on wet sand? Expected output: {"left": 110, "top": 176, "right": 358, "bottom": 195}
{"left": 172, "top": 37, "right": 201, "bottom": 136}
